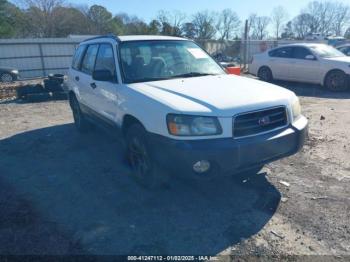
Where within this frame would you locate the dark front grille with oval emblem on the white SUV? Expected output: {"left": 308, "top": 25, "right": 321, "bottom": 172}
{"left": 233, "top": 106, "right": 288, "bottom": 138}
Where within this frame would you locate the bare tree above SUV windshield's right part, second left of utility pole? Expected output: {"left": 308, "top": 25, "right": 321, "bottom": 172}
{"left": 192, "top": 11, "right": 216, "bottom": 39}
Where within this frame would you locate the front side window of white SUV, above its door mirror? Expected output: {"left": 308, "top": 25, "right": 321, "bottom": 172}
{"left": 95, "top": 44, "right": 116, "bottom": 79}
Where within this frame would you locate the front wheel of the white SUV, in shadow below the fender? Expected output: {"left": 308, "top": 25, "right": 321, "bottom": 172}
{"left": 126, "top": 123, "right": 162, "bottom": 189}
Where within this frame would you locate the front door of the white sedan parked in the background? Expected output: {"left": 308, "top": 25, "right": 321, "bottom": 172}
{"left": 291, "top": 46, "right": 321, "bottom": 83}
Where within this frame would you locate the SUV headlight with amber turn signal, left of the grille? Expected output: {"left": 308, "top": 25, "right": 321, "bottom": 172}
{"left": 167, "top": 114, "right": 222, "bottom": 136}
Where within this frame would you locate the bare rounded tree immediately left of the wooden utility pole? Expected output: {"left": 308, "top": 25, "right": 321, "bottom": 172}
{"left": 216, "top": 9, "right": 241, "bottom": 40}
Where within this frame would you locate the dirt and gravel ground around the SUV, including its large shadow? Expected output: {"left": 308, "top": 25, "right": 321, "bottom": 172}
{"left": 0, "top": 79, "right": 350, "bottom": 261}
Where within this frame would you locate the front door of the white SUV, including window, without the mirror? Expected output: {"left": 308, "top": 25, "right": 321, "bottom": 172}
{"left": 91, "top": 43, "right": 118, "bottom": 120}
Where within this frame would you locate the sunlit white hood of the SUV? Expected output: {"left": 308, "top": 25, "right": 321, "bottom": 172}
{"left": 129, "top": 75, "right": 295, "bottom": 117}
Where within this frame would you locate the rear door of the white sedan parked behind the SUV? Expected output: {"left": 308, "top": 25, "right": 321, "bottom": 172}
{"left": 269, "top": 46, "right": 292, "bottom": 80}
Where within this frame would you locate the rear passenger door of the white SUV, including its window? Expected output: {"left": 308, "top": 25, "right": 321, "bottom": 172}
{"left": 78, "top": 44, "right": 99, "bottom": 111}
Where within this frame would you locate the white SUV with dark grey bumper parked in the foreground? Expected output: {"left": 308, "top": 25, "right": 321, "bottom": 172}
{"left": 68, "top": 36, "right": 307, "bottom": 186}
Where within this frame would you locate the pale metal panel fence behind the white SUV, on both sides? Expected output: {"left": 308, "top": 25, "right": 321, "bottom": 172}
{"left": 0, "top": 36, "right": 350, "bottom": 78}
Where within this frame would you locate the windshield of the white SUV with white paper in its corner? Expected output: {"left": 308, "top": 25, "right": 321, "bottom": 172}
{"left": 120, "top": 41, "right": 225, "bottom": 83}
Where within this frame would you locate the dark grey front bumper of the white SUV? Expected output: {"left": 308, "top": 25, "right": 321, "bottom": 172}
{"left": 149, "top": 116, "right": 308, "bottom": 175}
